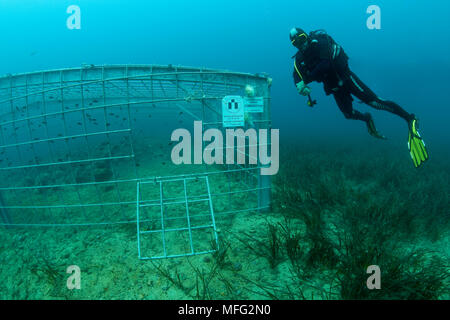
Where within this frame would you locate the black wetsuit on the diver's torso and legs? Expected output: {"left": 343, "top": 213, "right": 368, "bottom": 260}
{"left": 294, "top": 31, "right": 413, "bottom": 122}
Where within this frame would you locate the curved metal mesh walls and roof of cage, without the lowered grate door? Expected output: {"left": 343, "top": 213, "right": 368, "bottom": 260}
{"left": 0, "top": 65, "right": 271, "bottom": 226}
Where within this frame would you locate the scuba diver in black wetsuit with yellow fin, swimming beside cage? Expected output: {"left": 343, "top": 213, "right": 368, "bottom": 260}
{"left": 290, "top": 28, "right": 428, "bottom": 168}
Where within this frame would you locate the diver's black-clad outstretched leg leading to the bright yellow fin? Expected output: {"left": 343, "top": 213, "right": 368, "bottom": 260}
{"left": 347, "top": 71, "right": 414, "bottom": 123}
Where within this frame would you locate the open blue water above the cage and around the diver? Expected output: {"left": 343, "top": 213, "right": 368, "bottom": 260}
{"left": 0, "top": 0, "right": 450, "bottom": 150}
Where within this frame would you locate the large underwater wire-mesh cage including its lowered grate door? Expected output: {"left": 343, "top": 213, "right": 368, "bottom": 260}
{"left": 0, "top": 65, "right": 271, "bottom": 258}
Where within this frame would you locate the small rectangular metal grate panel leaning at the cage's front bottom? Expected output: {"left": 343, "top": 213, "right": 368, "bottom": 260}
{"left": 136, "top": 176, "right": 219, "bottom": 260}
